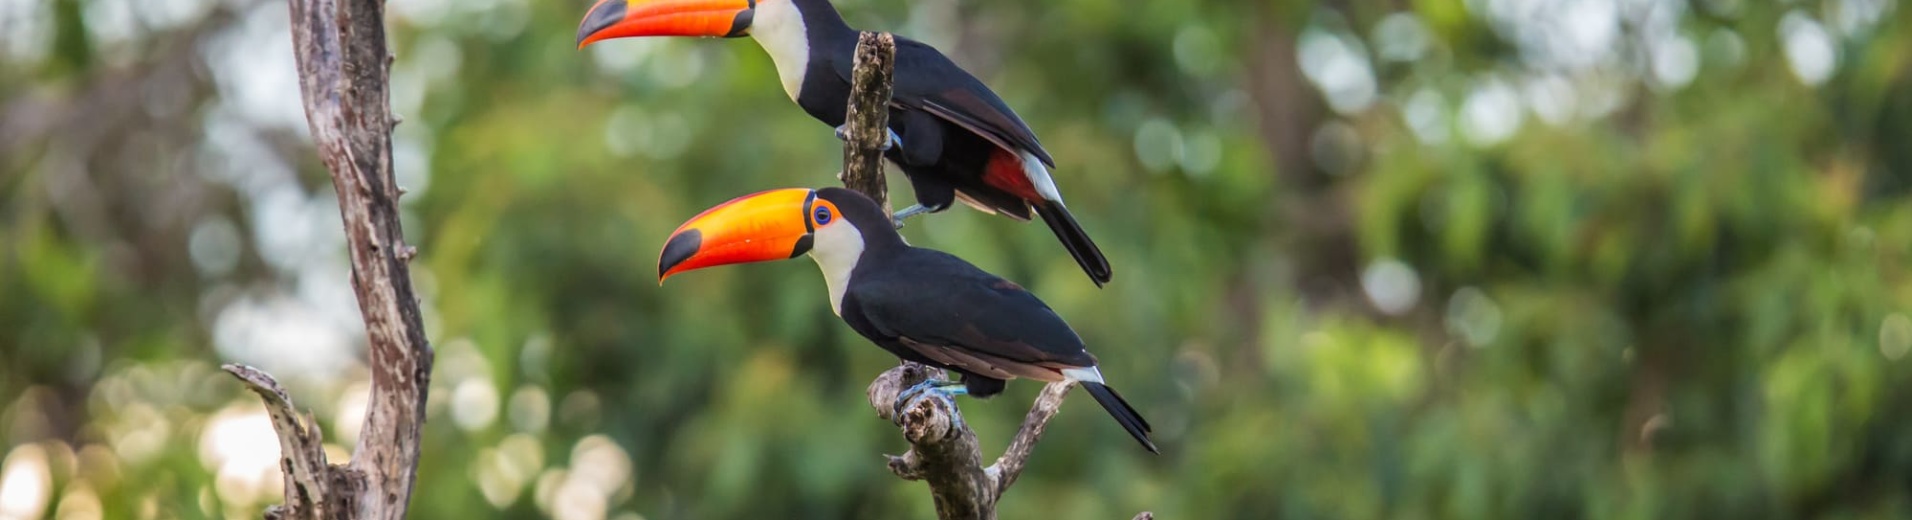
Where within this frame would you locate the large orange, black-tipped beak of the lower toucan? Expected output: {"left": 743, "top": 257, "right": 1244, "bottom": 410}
{"left": 658, "top": 187, "right": 816, "bottom": 283}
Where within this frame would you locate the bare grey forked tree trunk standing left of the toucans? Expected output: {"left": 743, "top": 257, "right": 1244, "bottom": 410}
{"left": 226, "top": 0, "right": 432, "bottom": 520}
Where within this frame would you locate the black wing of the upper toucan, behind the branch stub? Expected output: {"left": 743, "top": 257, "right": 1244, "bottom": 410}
{"left": 836, "top": 38, "right": 1055, "bottom": 168}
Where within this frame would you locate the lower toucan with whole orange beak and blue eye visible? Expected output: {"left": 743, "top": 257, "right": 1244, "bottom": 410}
{"left": 658, "top": 187, "right": 1157, "bottom": 451}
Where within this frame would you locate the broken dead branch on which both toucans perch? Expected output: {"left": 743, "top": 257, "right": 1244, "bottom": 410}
{"left": 843, "top": 33, "right": 1147, "bottom": 520}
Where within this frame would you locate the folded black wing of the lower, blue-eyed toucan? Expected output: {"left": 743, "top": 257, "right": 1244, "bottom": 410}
{"left": 849, "top": 249, "right": 1096, "bottom": 368}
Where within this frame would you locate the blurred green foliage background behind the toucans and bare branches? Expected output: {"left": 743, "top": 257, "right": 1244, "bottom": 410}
{"left": 0, "top": 0, "right": 1912, "bottom": 520}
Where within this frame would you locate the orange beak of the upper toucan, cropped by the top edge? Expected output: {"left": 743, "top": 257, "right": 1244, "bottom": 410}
{"left": 577, "top": 0, "right": 757, "bottom": 48}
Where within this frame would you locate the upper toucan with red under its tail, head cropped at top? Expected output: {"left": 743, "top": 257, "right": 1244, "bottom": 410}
{"left": 577, "top": 0, "right": 1113, "bottom": 287}
